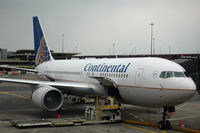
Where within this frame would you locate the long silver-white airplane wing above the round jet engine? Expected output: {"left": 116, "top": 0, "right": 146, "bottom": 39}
{"left": 0, "top": 78, "right": 96, "bottom": 95}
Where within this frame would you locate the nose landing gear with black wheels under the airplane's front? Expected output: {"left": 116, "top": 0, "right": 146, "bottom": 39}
{"left": 158, "top": 107, "right": 175, "bottom": 130}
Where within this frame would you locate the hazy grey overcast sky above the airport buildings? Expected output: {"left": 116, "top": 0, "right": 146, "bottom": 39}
{"left": 0, "top": 0, "right": 200, "bottom": 55}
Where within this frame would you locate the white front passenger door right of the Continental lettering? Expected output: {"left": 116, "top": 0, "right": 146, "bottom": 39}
{"left": 135, "top": 68, "right": 144, "bottom": 86}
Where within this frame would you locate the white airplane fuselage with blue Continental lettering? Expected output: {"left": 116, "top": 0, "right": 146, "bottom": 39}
{"left": 36, "top": 57, "right": 196, "bottom": 107}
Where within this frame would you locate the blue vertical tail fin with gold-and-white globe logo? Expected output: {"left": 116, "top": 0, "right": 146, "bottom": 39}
{"left": 33, "top": 16, "right": 52, "bottom": 65}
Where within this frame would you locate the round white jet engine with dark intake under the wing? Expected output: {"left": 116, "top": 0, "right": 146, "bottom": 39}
{"left": 32, "top": 86, "right": 64, "bottom": 111}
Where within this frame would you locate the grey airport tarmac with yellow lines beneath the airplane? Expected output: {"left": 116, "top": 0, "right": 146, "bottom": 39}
{"left": 0, "top": 75, "right": 200, "bottom": 133}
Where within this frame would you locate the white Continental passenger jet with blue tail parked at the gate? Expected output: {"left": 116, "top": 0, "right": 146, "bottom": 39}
{"left": 0, "top": 16, "right": 196, "bottom": 129}
